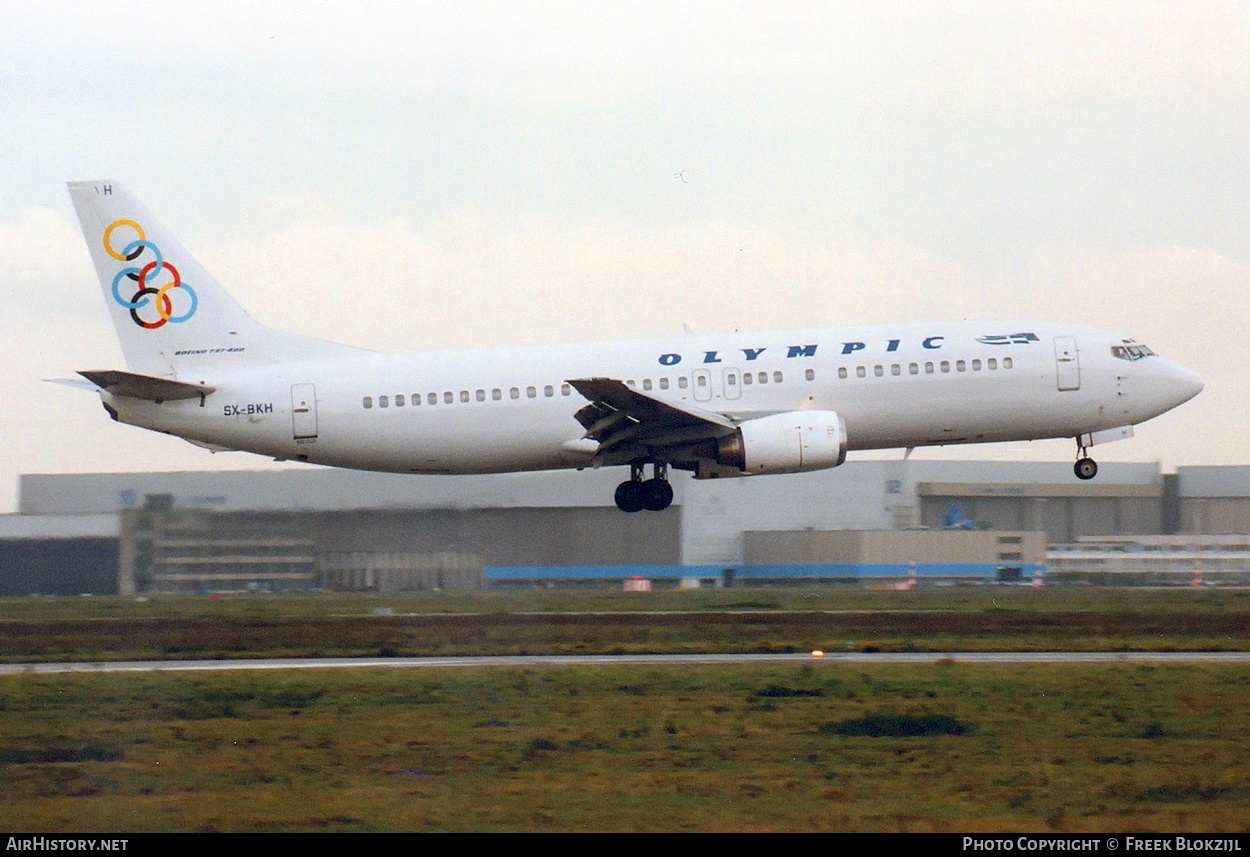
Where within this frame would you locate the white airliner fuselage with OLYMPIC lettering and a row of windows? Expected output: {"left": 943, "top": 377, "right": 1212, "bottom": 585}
{"left": 103, "top": 321, "right": 1201, "bottom": 473}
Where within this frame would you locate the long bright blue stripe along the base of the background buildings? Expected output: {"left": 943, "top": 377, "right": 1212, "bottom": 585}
{"left": 483, "top": 562, "right": 1010, "bottom": 581}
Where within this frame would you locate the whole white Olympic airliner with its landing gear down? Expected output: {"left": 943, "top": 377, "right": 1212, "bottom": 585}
{"left": 69, "top": 181, "right": 1203, "bottom": 512}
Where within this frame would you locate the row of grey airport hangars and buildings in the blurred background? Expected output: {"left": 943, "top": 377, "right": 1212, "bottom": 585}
{"left": 0, "top": 458, "right": 1250, "bottom": 596}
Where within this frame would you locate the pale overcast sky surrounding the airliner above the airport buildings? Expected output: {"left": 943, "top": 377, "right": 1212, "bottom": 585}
{"left": 0, "top": 0, "right": 1250, "bottom": 511}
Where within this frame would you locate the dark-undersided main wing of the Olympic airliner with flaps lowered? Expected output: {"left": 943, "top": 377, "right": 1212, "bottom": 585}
{"left": 569, "top": 379, "right": 738, "bottom": 465}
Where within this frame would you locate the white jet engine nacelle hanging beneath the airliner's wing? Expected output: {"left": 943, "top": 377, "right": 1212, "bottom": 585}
{"left": 716, "top": 411, "right": 846, "bottom": 476}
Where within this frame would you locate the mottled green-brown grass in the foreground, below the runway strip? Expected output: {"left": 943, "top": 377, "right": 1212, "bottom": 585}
{"left": 0, "top": 663, "right": 1250, "bottom": 832}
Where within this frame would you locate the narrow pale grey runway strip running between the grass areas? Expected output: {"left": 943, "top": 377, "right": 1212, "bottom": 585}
{"left": 0, "top": 652, "right": 1250, "bottom": 676}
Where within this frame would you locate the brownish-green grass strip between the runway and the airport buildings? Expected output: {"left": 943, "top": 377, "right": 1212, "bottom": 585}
{"left": 0, "top": 587, "right": 1250, "bottom": 662}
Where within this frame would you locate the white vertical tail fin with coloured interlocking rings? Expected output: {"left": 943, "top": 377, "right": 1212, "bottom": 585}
{"left": 69, "top": 180, "right": 360, "bottom": 377}
